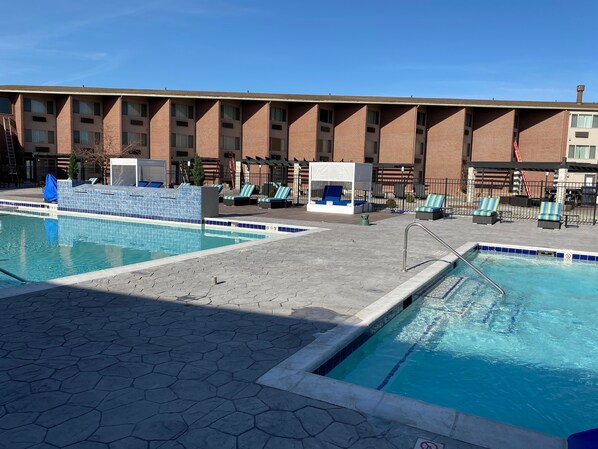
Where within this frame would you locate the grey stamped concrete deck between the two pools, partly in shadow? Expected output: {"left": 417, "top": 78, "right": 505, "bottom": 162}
{"left": 0, "top": 192, "right": 598, "bottom": 449}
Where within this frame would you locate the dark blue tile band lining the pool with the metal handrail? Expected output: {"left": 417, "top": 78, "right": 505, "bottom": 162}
{"left": 312, "top": 243, "right": 598, "bottom": 376}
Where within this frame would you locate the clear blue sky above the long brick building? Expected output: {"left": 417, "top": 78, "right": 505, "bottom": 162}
{"left": 0, "top": 0, "right": 598, "bottom": 102}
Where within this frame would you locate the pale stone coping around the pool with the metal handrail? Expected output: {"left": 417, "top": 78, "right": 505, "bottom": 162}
{"left": 257, "top": 242, "right": 567, "bottom": 449}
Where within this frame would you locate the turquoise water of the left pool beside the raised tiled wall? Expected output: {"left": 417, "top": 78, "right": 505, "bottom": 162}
{"left": 0, "top": 213, "right": 267, "bottom": 288}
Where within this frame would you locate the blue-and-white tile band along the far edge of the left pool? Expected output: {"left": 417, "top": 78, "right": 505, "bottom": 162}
{"left": 0, "top": 200, "right": 313, "bottom": 234}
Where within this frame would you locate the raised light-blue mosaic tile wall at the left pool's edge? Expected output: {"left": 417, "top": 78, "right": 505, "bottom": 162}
{"left": 58, "top": 180, "right": 218, "bottom": 224}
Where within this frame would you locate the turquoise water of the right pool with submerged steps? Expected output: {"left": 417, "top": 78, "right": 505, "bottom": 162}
{"left": 328, "top": 253, "right": 598, "bottom": 437}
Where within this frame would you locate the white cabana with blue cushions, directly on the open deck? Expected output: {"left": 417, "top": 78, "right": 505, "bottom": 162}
{"left": 307, "top": 162, "right": 372, "bottom": 214}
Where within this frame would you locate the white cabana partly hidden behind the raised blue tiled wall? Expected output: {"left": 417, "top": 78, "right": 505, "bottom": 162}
{"left": 110, "top": 158, "right": 166, "bottom": 186}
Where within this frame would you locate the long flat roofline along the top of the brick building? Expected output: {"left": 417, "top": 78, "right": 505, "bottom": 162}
{"left": 0, "top": 85, "right": 598, "bottom": 111}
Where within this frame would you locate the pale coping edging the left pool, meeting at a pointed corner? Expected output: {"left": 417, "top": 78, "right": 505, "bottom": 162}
{"left": 0, "top": 206, "right": 329, "bottom": 299}
